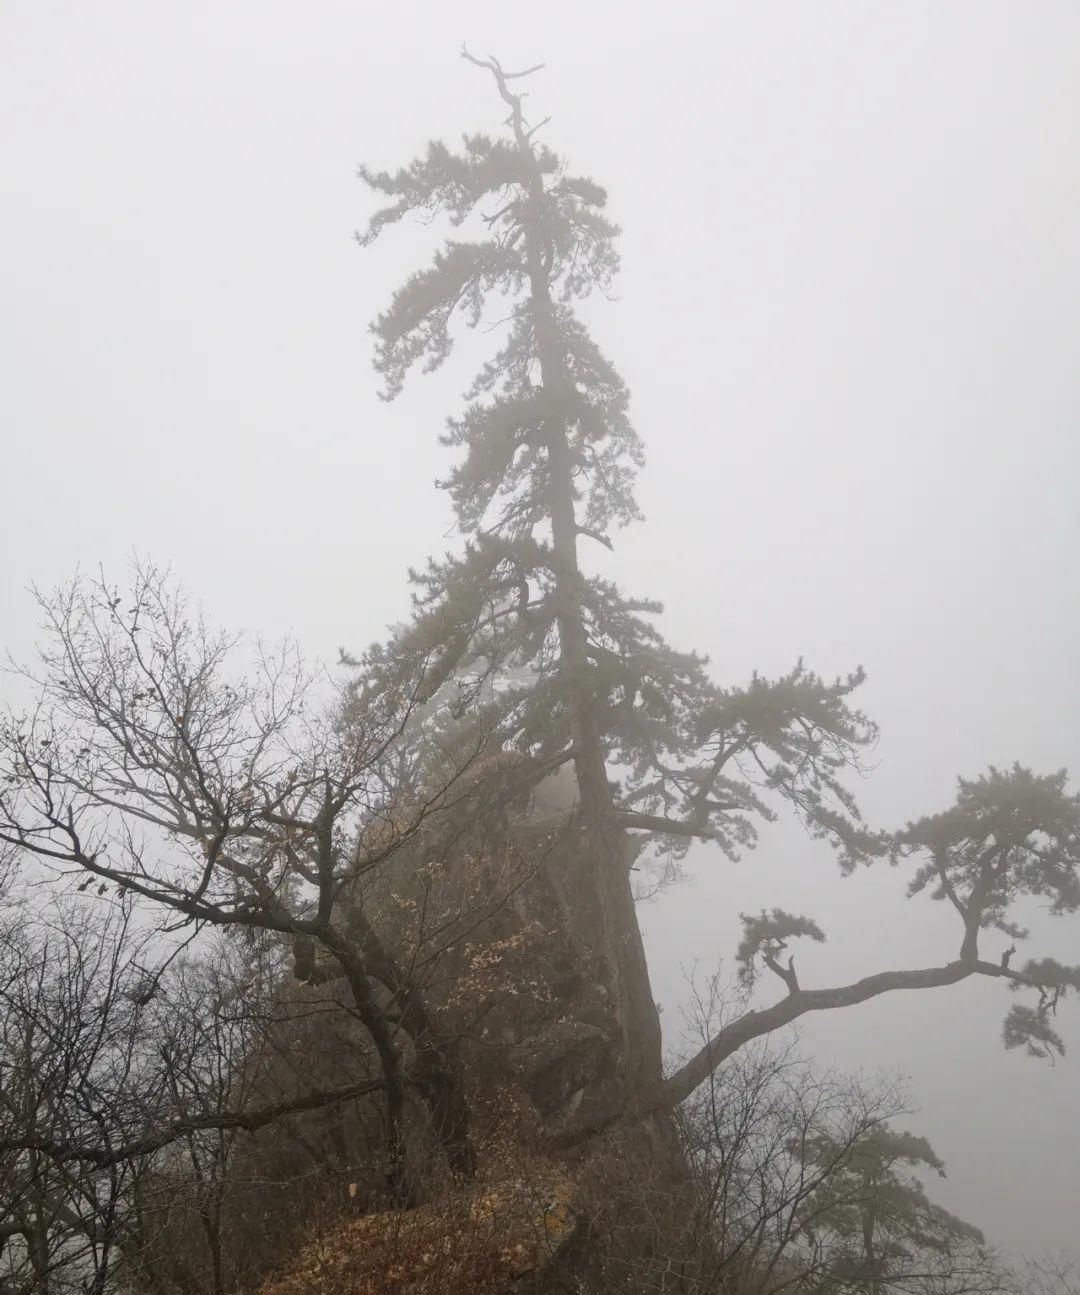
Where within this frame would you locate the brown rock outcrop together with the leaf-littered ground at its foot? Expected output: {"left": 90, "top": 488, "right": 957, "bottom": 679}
{"left": 260, "top": 771, "right": 686, "bottom": 1295}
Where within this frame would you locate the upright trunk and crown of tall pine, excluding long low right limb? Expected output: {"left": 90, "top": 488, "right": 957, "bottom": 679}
{"left": 361, "top": 53, "right": 882, "bottom": 1124}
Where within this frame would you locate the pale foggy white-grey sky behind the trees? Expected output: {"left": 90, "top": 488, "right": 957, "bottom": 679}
{"left": 0, "top": 0, "right": 1080, "bottom": 1250}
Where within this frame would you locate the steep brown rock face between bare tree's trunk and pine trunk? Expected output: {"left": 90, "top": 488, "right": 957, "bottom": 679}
{"left": 356, "top": 752, "right": 620, "bottom": 1137}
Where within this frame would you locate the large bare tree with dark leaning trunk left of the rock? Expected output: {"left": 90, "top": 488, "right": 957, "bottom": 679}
{"left": 0, "top": 567, "right": 486, "bottom": 1193}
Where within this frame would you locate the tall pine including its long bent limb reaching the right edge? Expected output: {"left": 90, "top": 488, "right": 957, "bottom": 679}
{"left": 360, "top": 51, "right": 1080, "bottom": 1131}
